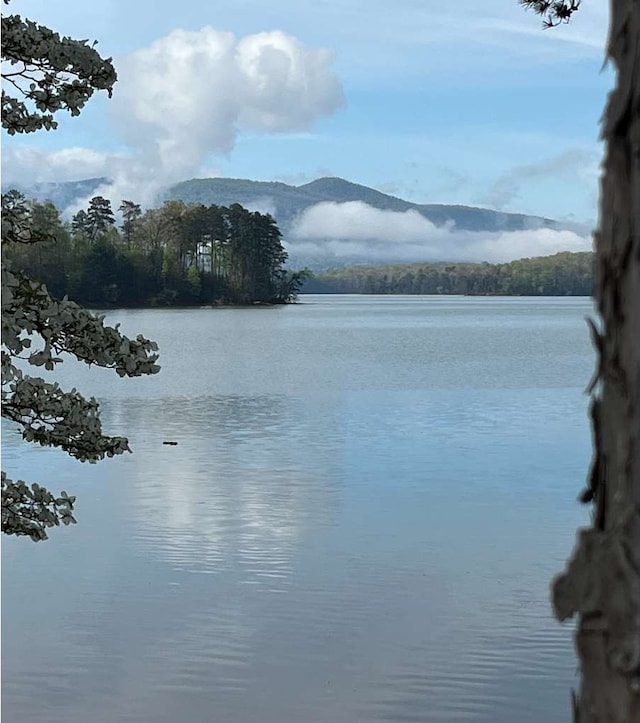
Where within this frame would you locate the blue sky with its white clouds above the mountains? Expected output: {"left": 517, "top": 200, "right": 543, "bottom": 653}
{"left": 3, "top": 0, "right": 612, "bottom": 223}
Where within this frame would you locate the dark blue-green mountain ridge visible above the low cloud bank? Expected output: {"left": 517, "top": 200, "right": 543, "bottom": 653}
{"left": 161, "top": 178, "right": 562, "bottom": 236}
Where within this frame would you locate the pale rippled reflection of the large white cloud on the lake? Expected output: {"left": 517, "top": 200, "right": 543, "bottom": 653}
{"left": 105, "top": 395, "right": 340, "bottom": 588}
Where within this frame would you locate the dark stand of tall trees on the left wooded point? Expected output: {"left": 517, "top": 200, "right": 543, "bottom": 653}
{"left": 2, "top": 191, "right": 307, "bottom": 306}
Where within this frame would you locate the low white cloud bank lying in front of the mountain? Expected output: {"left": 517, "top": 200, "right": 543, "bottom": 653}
{"left": 286, "top": 201, "right": 592, "bottom": 264}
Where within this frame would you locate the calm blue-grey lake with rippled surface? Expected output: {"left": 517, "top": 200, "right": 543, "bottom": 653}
{"left": 2, "top": 295, "right": 593, "bottom": 723}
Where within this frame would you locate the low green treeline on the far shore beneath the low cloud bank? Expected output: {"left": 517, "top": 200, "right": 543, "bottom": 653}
{"left": 303, "top": 252, "right": 593, "bottom": 296}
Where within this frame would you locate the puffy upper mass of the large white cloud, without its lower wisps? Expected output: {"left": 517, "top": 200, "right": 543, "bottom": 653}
{"left": 113, "top": 27, "right": 344, "bottom": 178}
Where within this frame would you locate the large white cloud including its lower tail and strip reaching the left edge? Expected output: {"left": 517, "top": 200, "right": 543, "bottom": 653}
{"left": 3, "top": 27, "right": 344, "bottom": 210}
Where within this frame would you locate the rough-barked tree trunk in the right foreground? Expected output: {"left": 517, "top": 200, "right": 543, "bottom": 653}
{"left": 552, "top": 0, "right": 640, "bottom": 723}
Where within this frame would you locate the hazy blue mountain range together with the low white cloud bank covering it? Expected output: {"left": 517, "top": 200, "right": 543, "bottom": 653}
{"left": 5, "top": 178, "right": 590, "bottom": 271}
